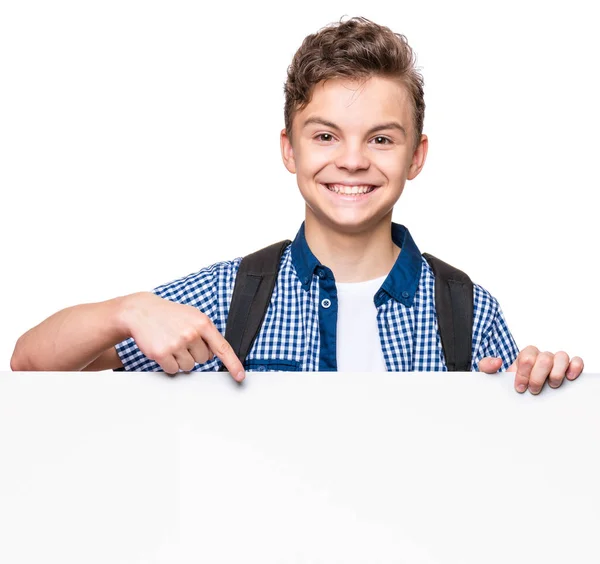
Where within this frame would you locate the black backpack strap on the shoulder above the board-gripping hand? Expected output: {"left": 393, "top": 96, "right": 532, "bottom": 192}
{"left": 423, "top": 253, "right": 473, "bottom": 372}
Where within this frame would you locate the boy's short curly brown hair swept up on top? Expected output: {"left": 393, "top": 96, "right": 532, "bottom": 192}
{"left": 284, "top": 17, "right": 425, "bottom": 147}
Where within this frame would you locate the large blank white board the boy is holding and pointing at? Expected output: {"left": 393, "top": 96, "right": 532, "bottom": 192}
{"left": 0, "top": 373, "right": 600, "bottom": 564}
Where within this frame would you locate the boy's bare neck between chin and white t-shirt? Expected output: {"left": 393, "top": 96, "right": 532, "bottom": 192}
{"left": 304, "top": 209, "right": 400, "bottom": 283}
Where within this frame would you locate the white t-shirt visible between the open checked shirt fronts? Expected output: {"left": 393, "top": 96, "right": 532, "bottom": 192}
{"left": 335, "top": 276, "right": 386, "bottom": 372}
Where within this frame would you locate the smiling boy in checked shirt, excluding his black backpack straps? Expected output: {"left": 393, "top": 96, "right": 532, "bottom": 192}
{"left": 11, "top": 18, "right": 583, "bottom": 393}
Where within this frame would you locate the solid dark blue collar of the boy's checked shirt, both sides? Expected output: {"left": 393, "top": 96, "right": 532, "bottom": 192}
{"left": 292, "top": 222, "right": 423, "bottom": 307}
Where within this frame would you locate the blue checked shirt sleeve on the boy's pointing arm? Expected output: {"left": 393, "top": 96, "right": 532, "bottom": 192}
{"left": 115, "top": 258, "right": 241, "bottom": 372}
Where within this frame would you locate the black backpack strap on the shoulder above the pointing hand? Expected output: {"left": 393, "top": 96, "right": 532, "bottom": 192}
{"left": 220, "top": 240, "right": 291, "bottom": 372}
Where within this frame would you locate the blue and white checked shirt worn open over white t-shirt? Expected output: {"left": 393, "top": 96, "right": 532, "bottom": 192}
{"left": 116, "top": 223, "right": 518, "bottom": 371}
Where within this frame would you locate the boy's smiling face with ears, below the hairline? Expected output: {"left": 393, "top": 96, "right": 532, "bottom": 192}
{"left": 281, "top": 77, "right": 427, "bottom": 233}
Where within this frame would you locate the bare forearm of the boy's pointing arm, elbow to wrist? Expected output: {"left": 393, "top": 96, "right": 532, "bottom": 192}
{"left": 10, "top": 294, "right": 135, "bottom": 371}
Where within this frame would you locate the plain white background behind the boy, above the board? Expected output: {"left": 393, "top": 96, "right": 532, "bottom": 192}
{"left": 0, "top": 0, "right": 600, "bottom": 372}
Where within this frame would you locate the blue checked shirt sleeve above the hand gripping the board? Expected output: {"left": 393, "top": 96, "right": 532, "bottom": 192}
{"left": 471, "top": 284, "right": 519, "bottom": 371}
